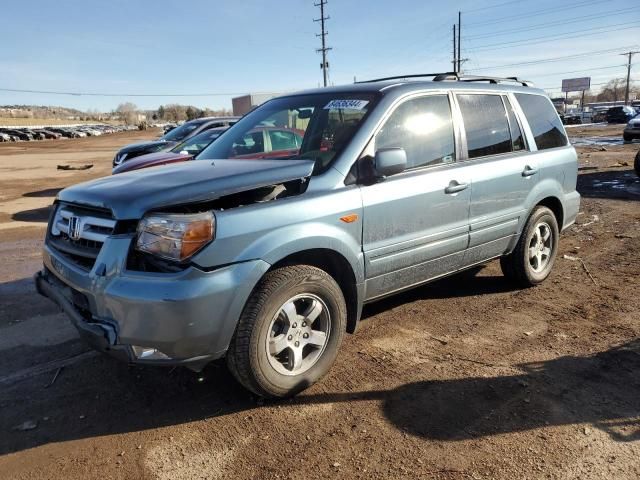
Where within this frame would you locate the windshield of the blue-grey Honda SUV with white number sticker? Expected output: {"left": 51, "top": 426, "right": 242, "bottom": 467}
{"left": 198, "top": 93, "right": 377, "bottom": 173}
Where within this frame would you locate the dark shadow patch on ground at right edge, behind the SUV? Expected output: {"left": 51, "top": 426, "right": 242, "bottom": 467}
{"left": 576, "top": 169, "right": 640, "bottom": 201}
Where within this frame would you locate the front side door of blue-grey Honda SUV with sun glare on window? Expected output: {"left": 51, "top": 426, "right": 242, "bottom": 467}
{"left": 361, "top": 93, "right": 471, "bottom": 300}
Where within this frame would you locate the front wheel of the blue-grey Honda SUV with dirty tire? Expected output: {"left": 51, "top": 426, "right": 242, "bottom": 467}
{"left": 227, "top": 265, "right": 347, "bottom": 397}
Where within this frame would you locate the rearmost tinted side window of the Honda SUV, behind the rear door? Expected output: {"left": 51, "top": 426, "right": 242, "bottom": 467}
{"left": 515, "top": 93, "right": 568, "bottom": 150}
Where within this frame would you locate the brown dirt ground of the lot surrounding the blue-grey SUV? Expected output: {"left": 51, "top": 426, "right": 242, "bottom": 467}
{"left": 0, "top": 127, "right": 640, "bottom": 480}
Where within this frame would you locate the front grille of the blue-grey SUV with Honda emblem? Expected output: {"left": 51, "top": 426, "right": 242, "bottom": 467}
{"left": 47, "top": 204, "right": 116, "bottom": 270}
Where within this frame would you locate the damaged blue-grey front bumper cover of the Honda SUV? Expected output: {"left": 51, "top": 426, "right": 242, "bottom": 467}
{"left": 35, "top": 240, "right": 270, "bottom": 368}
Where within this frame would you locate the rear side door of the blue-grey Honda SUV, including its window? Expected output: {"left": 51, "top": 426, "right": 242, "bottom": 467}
{"left": 456, "top": 92, "right": 540, "bottom": 265}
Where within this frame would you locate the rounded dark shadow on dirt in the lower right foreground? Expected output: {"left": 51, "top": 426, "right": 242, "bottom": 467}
{"left": 297, "top": 339, "right": 640, "bottom": 442}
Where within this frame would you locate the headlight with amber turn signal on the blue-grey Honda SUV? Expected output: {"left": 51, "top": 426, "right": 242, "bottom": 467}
{"left": 136, "top": 212, "right": 215, "bottom": 261}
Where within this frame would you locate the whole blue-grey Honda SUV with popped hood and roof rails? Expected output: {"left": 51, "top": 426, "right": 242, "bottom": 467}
{"left": 35, "top": 74, "right": 580, "bottom": 397}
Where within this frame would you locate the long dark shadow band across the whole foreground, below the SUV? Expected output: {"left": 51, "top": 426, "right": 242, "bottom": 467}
{"left": 0, "top": 298, "right": 640, "bottom": 455}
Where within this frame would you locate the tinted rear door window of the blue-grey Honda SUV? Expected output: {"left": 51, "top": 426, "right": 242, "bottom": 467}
{"left": 457, "top": 94, "right": 512, "bottom": 158}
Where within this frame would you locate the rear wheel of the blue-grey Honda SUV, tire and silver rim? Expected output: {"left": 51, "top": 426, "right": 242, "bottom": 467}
{"left": 500, "top": 206, "right": 560, "bottom": 287}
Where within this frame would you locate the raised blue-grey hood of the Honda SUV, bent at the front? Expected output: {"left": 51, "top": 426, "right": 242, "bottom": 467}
{"left": 58, "top": 159, "right": 314, "bottom": 220}
